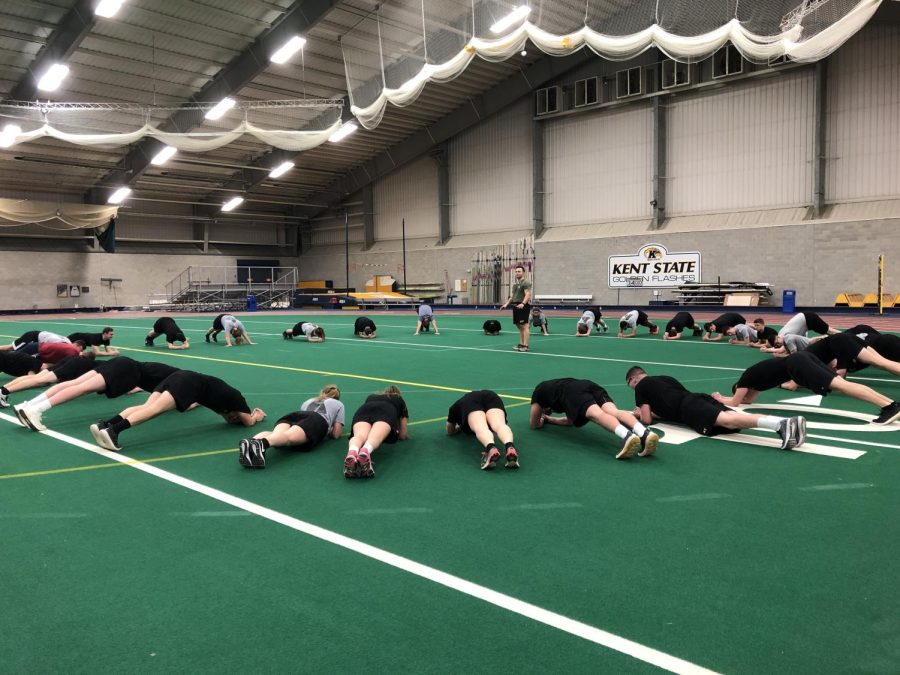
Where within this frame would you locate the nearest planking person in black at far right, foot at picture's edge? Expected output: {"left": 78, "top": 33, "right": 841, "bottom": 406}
{"left": 713, "top": 351, "right": 900, "bottom": 424}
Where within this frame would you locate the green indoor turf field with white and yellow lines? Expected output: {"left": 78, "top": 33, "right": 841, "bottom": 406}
{"left": 0, "top": 312, "right": 900, "bottom": 673}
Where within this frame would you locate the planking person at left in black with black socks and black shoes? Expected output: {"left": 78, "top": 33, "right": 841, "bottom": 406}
{"left": 91, "top": 370, "right": 266, "bottom": 452}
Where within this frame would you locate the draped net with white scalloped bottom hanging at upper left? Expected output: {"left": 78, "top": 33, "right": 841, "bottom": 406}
{"left": 0, "top": 99, "right": 343, "bottom": 152}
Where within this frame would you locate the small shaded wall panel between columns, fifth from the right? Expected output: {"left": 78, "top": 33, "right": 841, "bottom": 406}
{"left": 375, "top": 156, "right": 439, "bottom": 241}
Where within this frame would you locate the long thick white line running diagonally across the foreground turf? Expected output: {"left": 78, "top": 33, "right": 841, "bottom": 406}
{"left": 0, "top": 413, "right": 715, "bottom": 675}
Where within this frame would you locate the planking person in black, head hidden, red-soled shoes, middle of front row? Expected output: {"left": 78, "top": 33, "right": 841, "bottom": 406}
{"left": 447, "top": 389, "right": 519, "bottom": 471}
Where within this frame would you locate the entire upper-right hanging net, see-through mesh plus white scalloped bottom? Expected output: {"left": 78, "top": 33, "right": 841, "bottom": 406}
{"left": 341, "top": 0, "right": 881, "bottom": 129}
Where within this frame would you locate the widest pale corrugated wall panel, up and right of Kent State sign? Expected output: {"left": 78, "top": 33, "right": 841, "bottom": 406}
{"left": 666, "top": 70, "right": 815, "bottom": 216}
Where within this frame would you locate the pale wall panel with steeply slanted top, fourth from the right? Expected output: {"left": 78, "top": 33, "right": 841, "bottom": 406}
{"left": 450, "top": 97, "right": 533, "bottom": 234}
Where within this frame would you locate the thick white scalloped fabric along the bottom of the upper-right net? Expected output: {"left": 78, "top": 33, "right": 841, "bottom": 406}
{"left": 344, "top": 0, "right": 882, "bottom": 129}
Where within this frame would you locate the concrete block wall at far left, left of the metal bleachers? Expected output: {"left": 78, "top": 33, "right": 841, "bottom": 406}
{"left": 0, "top": 251, "right": 296, "bottom": 310}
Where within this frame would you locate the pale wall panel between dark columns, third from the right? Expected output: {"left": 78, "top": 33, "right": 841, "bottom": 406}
{"left": 544, "top": 106, "right": 653, "bottom": 226}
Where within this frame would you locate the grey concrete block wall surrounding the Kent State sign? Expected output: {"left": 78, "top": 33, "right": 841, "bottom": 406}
{"left": 299, "top": 219, "right": 900, "bottom": 307}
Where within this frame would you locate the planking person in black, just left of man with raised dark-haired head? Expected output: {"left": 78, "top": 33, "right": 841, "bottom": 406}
{"left": 531, "top": 377, "right": 659, "bottom": 459}
